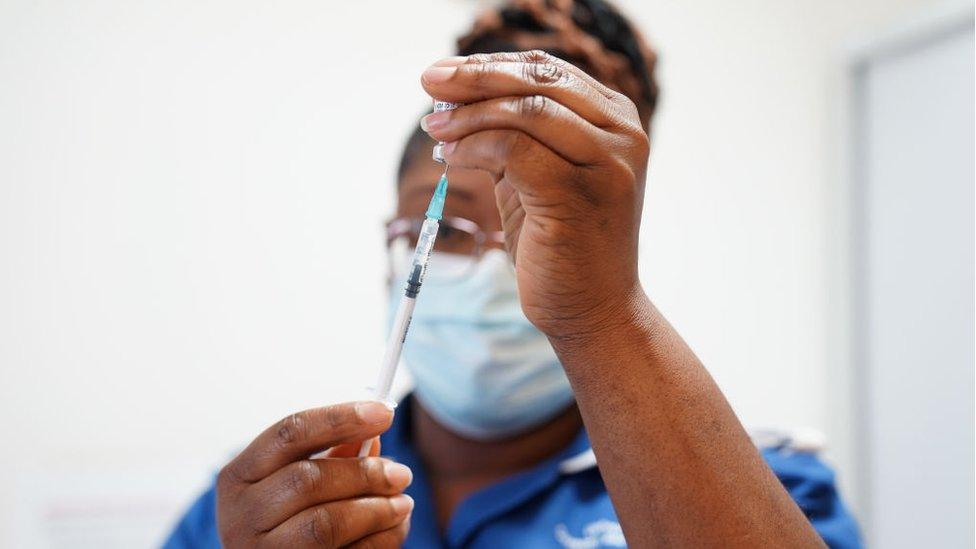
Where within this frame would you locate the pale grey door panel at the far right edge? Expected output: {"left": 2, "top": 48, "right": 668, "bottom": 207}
{"left": 855, "top": 15, "right": 976, "bottom": 549}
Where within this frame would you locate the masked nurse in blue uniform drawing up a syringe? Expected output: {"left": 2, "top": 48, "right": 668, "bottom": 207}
{"left": 166, "top": 0, "right": 859, "bottom": 548}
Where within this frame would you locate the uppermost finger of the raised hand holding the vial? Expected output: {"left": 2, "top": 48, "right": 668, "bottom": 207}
{"left": 421, "top": 51, "right": 624, "bottom": 128}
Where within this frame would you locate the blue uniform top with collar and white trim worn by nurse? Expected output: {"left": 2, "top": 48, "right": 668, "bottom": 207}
{"left": 164, "top": 398, "right": 861, "bottom": 549}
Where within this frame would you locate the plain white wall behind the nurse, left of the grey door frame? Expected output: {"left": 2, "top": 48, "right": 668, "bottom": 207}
{"left": 0, "top": 0, "right": 944, "bottom": 547}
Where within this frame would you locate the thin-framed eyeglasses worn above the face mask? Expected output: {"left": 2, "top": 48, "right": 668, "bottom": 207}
{"left": 386, "top": 217, "right": 505, "bottom": 281}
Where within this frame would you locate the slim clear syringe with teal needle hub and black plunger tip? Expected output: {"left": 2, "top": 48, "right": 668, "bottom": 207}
{"left": 359, "top": 169, "right": 447, "bottom": 457}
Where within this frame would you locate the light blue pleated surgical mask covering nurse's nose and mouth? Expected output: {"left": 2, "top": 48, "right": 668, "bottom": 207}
{"left": 390, "top": 250, "right": 573, "bottom": 440}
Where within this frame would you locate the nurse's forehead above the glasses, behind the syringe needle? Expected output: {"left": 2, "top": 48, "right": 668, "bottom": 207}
{"left": 396, "top": 156, "right": 502, "bottom": 232}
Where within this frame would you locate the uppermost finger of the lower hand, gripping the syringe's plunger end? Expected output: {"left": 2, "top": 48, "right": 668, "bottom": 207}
{"left": 224, "top": 401, "right": 393, "bottom": 482}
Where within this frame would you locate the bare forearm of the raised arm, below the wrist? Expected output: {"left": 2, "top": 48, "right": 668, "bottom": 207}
{"left": 552, "top": 290, "right": 822, "bottom": 547}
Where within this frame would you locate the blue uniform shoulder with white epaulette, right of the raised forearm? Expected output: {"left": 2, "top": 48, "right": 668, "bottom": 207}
{"left": 750, "top": 430, "right": 861, "bottom": 548}
